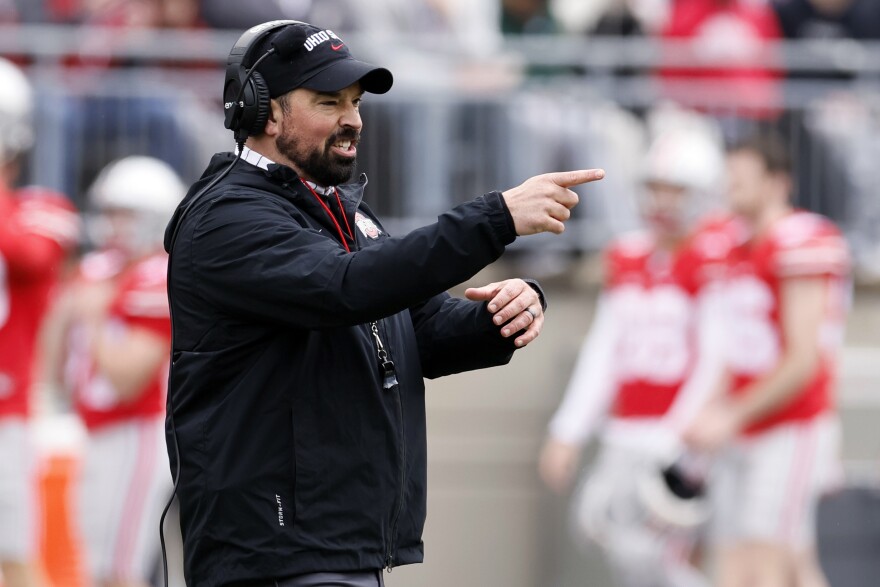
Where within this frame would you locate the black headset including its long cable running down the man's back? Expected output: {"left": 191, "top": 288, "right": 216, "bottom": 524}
{"left": 159, "top": 20, "right": 304, "bottom": 587}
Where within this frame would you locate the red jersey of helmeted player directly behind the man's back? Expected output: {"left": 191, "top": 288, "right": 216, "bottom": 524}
{"left": 66, "top": 253, "right": 171, "bottom": 429}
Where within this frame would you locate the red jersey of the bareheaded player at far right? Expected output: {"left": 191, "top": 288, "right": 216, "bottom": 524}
{"left": 726, "top": 211, "right": 850, "bottom": 433}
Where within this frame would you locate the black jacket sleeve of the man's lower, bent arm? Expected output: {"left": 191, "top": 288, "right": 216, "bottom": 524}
{"left": 410, "top": 293, "right": 516, "bottom": 379}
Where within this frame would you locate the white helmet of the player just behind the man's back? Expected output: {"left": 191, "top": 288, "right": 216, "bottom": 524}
{"left": 88, "top": 155, "right": 186, "bottom": 254}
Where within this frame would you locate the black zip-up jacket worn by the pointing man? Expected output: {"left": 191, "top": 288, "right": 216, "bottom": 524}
{"left": 166, "top": 154, "right": 540, "bottom": 586}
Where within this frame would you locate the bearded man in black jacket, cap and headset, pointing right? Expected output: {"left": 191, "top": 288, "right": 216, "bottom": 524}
{"left": 166, "top": 22, "right": 603, "bottom": 587}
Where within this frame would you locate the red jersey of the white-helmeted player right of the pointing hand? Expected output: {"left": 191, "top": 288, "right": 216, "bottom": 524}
{"left": 606, "top": 220, "right": 733, "bottom": 418}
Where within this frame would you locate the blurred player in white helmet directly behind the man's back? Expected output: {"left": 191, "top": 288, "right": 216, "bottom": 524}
{"left": 49, "top": 156, "right": 185, "bottom": 587}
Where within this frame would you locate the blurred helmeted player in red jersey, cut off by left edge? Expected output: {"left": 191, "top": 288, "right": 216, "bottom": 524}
{"left": 0, "top": 58, "right": 79, "bottom": 587}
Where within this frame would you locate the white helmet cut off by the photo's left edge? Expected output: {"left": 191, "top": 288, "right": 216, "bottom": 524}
{"left": 0, "top": 57, "right": 34, "bottom": 161}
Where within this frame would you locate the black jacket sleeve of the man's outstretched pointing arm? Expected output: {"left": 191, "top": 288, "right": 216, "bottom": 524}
{"left": 182, "top": 192, "right": 516, "bottom": 329}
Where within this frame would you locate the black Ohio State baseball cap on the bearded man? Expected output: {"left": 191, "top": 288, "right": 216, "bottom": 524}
{"left": 256, "top": 22, "right": 394, "bottom": 98}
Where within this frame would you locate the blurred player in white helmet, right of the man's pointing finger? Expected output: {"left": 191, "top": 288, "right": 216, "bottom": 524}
{"left": 539, "top": 128, "right": 730, "bottom": 587}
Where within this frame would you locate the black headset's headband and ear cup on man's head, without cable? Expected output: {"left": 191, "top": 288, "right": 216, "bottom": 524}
{"left": 223, "top": 20, "right": 304, "bottom": 142}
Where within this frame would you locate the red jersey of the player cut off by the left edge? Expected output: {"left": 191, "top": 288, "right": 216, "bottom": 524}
{"left": 0, "top": 188, "right": 79, "bottom": 417}
